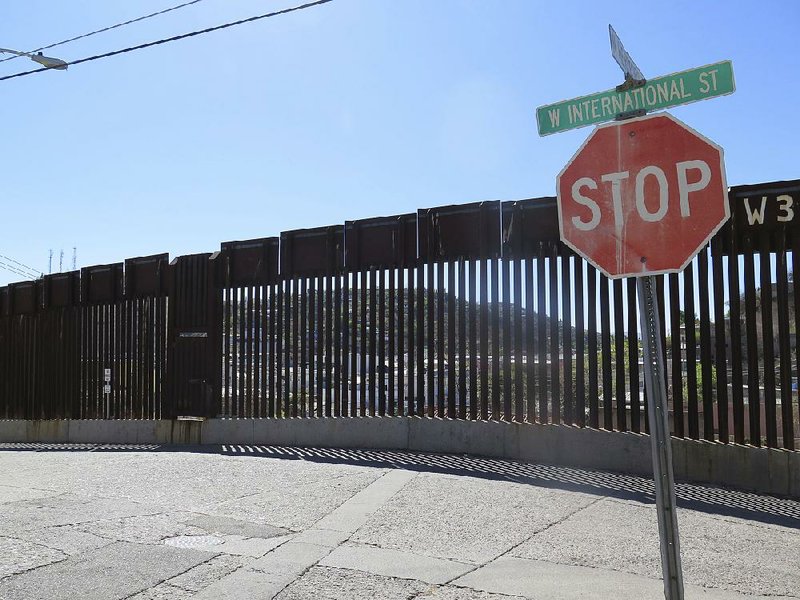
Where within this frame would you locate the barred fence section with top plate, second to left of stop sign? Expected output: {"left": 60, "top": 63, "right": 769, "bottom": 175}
{"left": 415, "top": 202, "right": 500, "bottom": 419}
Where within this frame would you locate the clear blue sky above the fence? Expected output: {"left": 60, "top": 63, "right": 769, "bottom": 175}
{"left": 0, "top": 0, "right": 800, "bottom": 285}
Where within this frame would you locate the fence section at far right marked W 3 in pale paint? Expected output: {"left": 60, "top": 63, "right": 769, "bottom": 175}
{"left": 717, "top": 181, "right": 800, "bottom": 449}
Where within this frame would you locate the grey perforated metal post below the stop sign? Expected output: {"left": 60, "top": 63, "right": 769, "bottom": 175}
{"left": 636, "top": 275, "right": 683, "bottom": 600}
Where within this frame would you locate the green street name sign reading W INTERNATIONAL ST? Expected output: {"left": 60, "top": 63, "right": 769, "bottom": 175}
{"left": 536, "top": 60, "right": 736, "bottom": 136}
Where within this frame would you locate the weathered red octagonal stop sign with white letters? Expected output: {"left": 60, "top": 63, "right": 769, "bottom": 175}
{"left": 557, "top": 113, "right": 730, "bottom": 278}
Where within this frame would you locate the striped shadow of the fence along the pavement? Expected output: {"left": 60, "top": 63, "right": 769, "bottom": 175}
{"left": 0, "top": 443, "right": 800, "bottom": 529}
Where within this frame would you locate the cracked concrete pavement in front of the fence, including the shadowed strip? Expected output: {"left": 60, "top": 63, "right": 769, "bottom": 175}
{"left": 0, "top": 444, "right": 800, "bottom": 600}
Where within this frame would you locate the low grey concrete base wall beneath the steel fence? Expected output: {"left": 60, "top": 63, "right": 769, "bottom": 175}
{"left": 0, "top": 417, "right": 800, "bottom": 499}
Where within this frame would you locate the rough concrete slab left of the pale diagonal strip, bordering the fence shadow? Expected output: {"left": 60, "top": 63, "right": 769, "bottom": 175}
{"left": 3, "top": 452, "right": 383, "bottom": 530}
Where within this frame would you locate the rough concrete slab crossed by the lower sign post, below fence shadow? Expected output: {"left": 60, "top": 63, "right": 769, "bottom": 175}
{"left": 512, "top": 500, "right": 800, "bottom": 596}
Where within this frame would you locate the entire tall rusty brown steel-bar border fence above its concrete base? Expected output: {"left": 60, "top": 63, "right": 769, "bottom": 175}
{"left": 0, "top": 180, "right": 800, "bottom": 449}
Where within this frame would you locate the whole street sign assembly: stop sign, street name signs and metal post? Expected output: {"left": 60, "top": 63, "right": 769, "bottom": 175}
{"left": 537, "top": 25, "right": 724, "bottom": 600}
